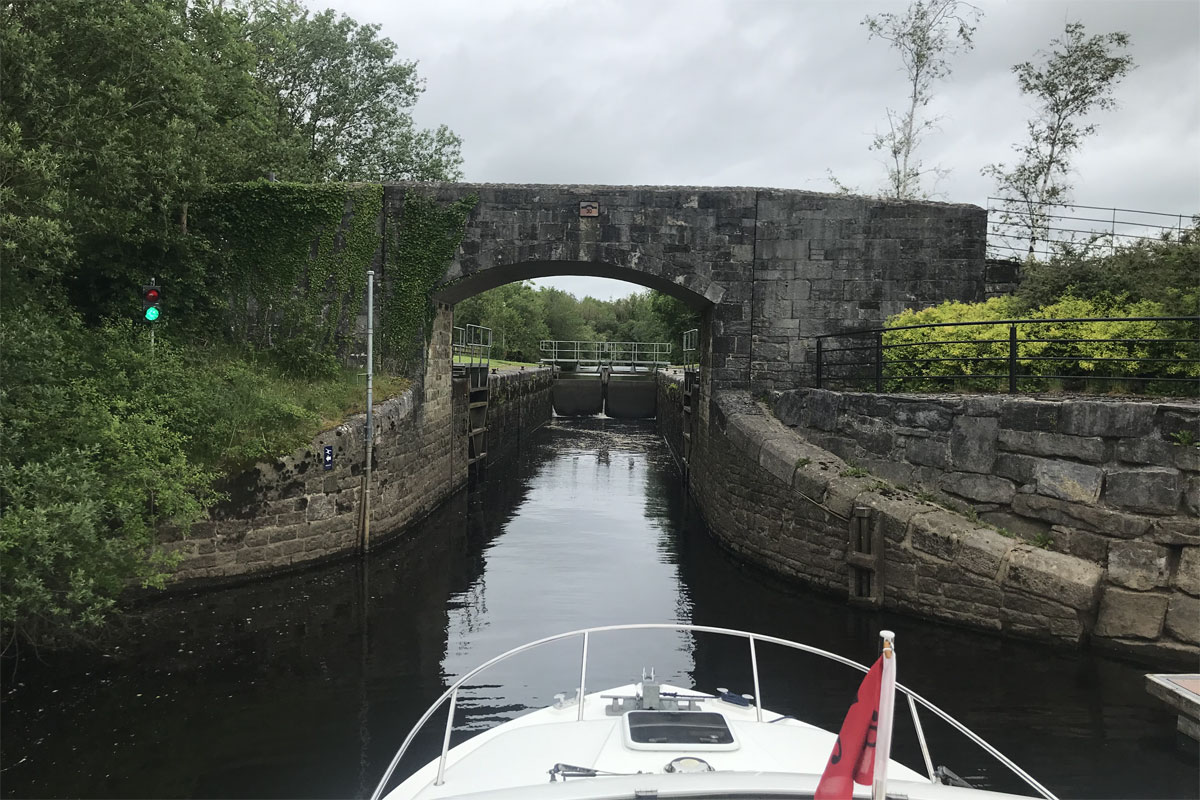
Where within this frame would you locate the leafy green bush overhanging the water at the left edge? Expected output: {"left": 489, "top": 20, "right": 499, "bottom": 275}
{"left": 0, "top": 306, "right": 212, "bottom": 642}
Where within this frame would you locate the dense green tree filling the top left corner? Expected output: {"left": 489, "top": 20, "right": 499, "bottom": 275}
{"left": 0, "top": 0, "right": 274, "bottom": 320}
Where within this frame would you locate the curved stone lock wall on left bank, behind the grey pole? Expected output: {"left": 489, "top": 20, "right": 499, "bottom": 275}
{"left": 163, "top": 331, "right": 551, "bottom": 585}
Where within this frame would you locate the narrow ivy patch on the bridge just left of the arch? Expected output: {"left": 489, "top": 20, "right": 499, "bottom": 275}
{"left": 379, "top": 191, "right": 479, "bottom": 365}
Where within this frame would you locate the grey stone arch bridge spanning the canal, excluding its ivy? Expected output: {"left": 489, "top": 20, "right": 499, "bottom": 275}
{"left": 384, "top": 184, "right": 986, "bottom": 390}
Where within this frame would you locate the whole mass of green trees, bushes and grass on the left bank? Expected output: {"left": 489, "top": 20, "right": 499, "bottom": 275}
{"left": 0, "top": 0, "right": 461, "bottom": 640}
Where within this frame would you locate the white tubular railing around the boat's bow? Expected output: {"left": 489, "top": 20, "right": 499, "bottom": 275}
{"left": 371, "top": 622, "right": 1057, "bottom": 800}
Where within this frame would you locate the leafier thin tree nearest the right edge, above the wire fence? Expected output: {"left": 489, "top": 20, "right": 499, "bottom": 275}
{"left": 983, "top": 22, "right": 1134, "bottom": 259}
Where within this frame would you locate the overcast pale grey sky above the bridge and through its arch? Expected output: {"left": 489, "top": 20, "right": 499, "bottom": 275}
{"left": 308, "top": 0, "right": 1200, "bottom": 297}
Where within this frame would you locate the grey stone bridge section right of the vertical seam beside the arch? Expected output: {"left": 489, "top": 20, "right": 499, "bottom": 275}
{"left": 748, "top": 190, "right": 988, "bottom": 391}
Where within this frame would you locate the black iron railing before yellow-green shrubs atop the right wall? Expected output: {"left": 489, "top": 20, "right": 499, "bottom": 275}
{"left": 814, "top": 317, "right": 1200, "bottom": 396}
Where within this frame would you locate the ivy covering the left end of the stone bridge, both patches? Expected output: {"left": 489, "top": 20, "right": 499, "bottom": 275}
{"left": 196, "top": 180, "right": 478, "bottom": 378}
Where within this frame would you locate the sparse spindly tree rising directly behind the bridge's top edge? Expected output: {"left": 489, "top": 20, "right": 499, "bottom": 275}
{"left": 864, "top": 0, "right": 983, "bottom": 200}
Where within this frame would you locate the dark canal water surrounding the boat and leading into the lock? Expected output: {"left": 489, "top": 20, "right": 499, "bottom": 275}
{"left": 0, "top": 420, "right": 1200, "bottom": 798}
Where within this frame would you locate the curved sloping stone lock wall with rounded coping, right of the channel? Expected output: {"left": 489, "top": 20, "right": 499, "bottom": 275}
{"left": 659, "top": 375, "right": 1200, "bottom": 664}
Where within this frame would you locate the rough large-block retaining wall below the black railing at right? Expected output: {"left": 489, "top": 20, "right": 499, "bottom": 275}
{"left": 773, "top": 390, "right": 1200, "bottom": 656}
